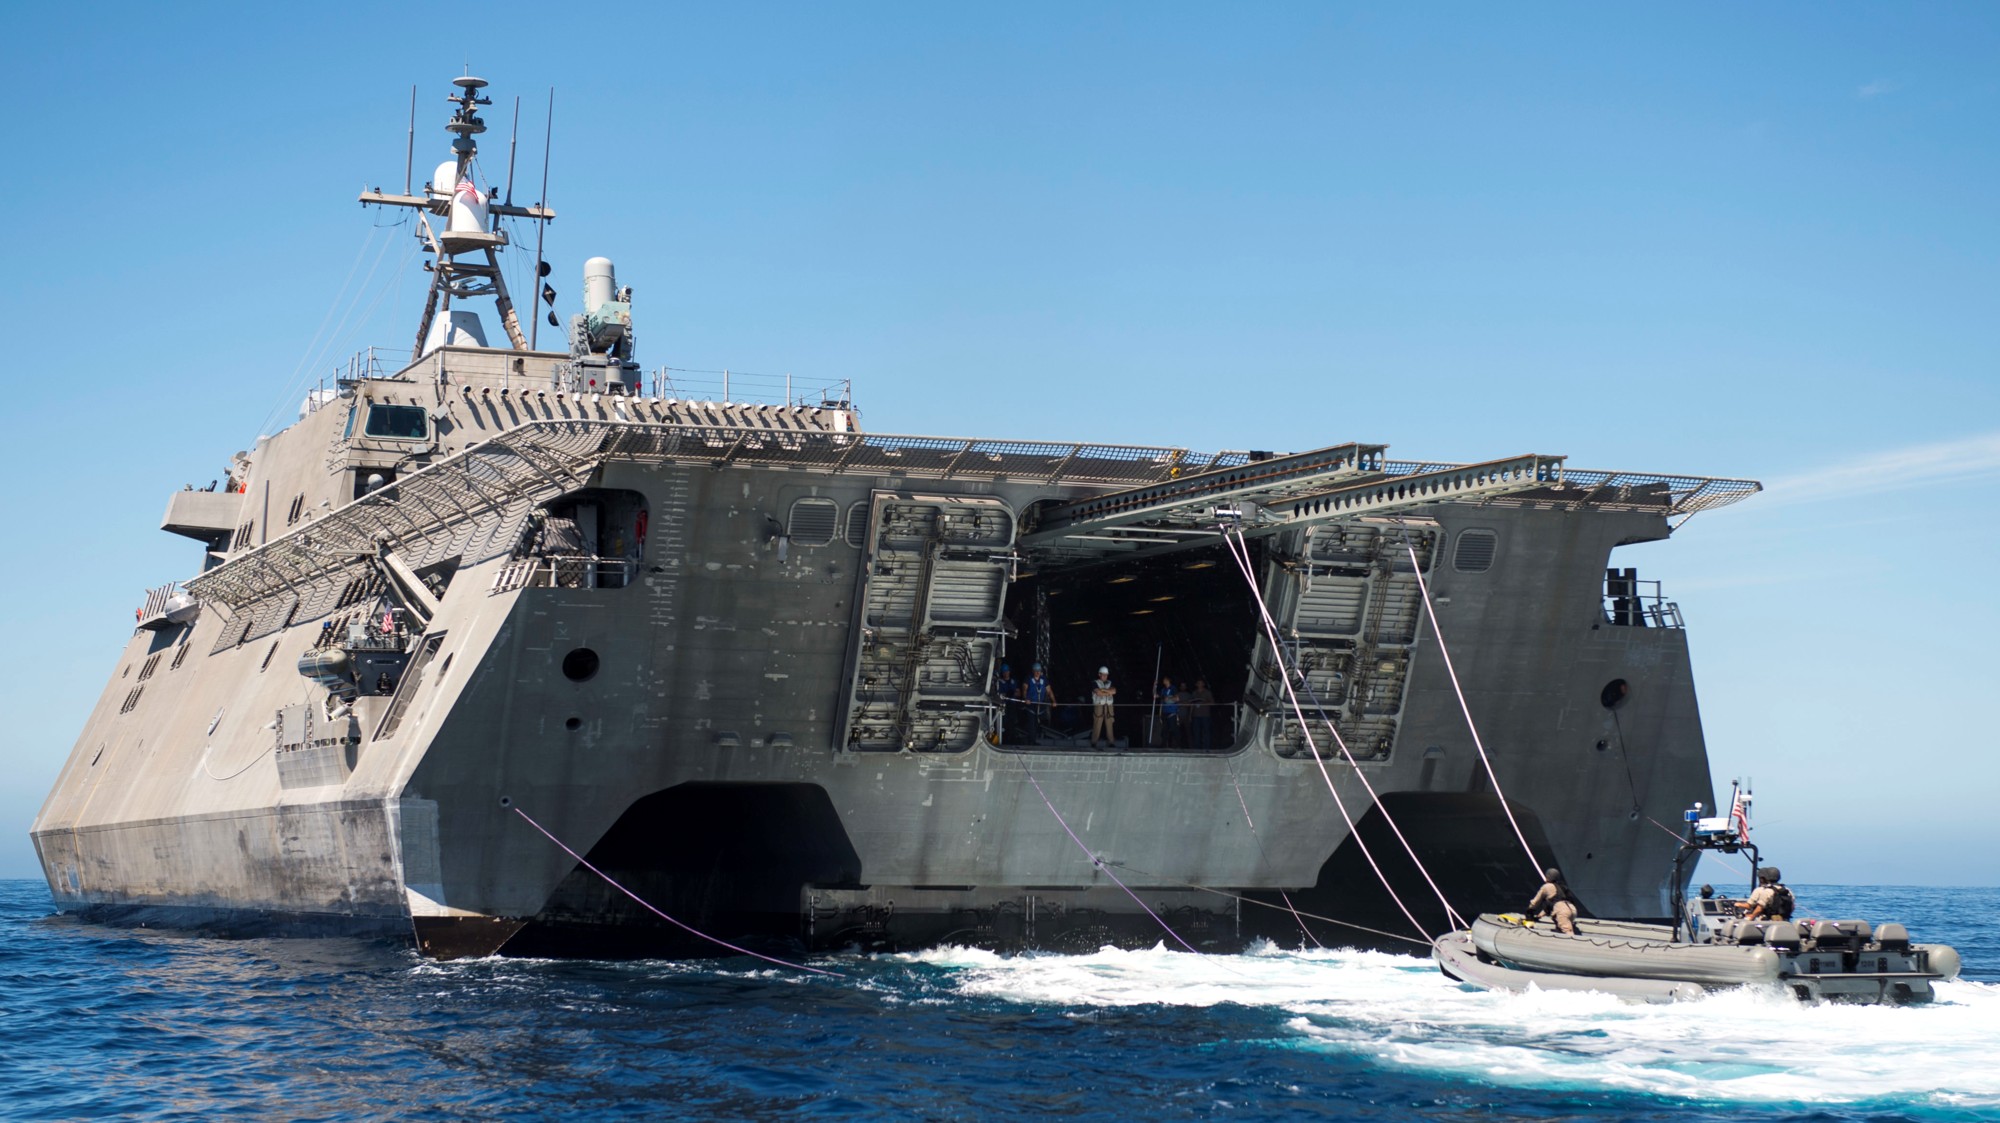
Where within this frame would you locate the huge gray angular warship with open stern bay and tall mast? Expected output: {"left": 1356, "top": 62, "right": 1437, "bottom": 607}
{"left": 34, "top": 78, "right": 1758, "bottom": 957}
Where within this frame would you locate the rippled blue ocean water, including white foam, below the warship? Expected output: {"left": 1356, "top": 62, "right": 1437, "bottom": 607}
{"left": 0, "top": 881, "right": 2000, "bottom": 1123}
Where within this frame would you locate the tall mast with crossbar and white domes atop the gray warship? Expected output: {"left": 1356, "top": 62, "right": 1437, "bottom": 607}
{"left": 360, "top": 76, "right": 556, "bottom": 358}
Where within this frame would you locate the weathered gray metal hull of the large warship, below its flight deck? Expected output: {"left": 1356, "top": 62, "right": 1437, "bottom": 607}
{"left": 23, "top": 383, "right": 1710, "bottom": 953}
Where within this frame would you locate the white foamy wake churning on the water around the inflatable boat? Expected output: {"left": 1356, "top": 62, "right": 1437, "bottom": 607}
{"left": 890, "top": 947, "right": 2000, "bottom": 1107}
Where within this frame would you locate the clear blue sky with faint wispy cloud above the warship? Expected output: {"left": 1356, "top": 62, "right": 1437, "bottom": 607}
{"left": 0, "top": 4, "right": 2000, "bottom": 885}
